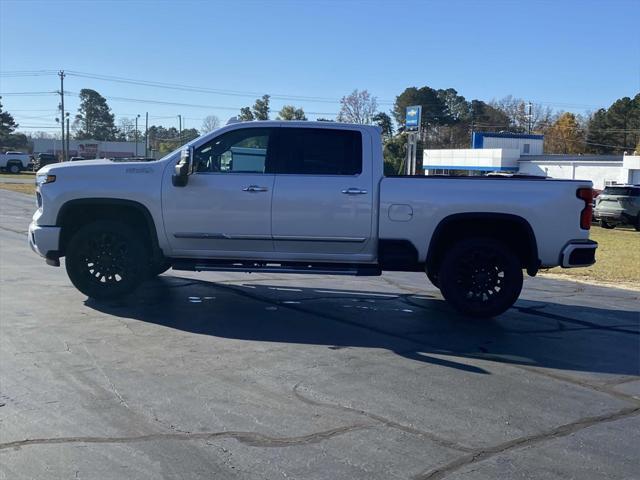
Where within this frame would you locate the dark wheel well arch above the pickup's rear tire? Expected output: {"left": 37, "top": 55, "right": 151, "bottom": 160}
{"left": 426, "top": 213, "right": 540, "bottom": 276}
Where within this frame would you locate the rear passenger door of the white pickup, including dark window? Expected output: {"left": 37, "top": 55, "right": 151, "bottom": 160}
{"left": 271, "top": 126, "right": 376, "bottom": 262}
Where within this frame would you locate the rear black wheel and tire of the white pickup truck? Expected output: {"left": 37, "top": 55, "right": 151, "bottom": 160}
{"left": 438, "top": 238, "right": 522, "bottom": 318}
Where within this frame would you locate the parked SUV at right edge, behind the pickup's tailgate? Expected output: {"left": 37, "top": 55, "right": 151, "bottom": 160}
{"left": 594, "top": 185, "right": 640, "bottom": 231}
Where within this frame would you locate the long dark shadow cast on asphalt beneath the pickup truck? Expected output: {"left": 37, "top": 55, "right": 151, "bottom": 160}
{"left": 86, "top": 275, "right": 640, "bottom": 375}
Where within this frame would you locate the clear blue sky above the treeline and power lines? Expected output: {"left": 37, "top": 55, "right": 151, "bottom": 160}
{"left": 0, "top": 0, "right": 640, "bottom": 131}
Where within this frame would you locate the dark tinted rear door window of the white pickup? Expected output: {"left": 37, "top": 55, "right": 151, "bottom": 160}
{"left": 278, "top": 128, "right": 362, "bottom": 175}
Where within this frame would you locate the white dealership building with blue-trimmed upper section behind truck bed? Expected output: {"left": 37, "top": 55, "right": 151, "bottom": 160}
{"left": 423, "top": 132, "right": 640, "bottom": 189}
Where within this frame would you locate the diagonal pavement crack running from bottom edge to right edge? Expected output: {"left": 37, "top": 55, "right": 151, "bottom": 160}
{"left": 413, "top": 407, "right": 640, "bottom": 480}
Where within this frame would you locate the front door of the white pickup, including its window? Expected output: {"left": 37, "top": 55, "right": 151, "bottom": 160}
{"left": 162, "top": 127, "right": 274, "bottom": 258}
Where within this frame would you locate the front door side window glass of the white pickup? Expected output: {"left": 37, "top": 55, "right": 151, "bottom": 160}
{"left": 194, "top": 128, "right": 272, "bottom": 173}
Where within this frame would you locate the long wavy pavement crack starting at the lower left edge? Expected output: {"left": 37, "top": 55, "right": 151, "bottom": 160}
{"left": 0, "top": 424, "right": 373, "bottom": 450}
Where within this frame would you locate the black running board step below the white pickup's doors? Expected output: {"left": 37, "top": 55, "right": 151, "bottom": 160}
{"left": 171, "top": 258, "right": 382, "bottom": 277}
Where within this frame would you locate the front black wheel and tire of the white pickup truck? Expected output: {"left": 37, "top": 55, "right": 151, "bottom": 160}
{"left": 65, "top": 220, "right": 149, "bottom": 299}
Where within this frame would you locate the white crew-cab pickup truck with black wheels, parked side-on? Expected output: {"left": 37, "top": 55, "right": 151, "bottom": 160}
{"left": 29, "top": 121, "right": 597, "bottom": 317}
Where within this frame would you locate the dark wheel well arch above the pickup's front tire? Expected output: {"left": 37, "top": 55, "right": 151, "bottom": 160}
{"left": 56, "top": 199, "right": 162, "bottom": 259}
